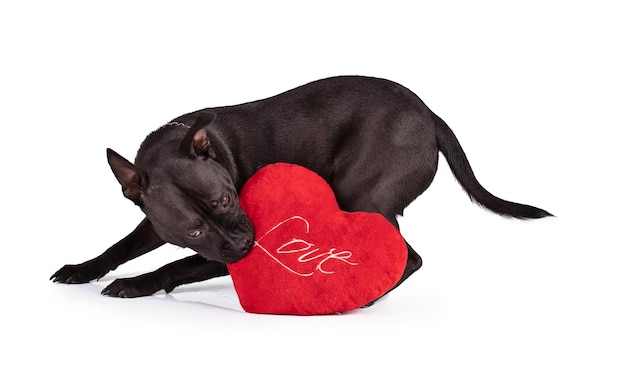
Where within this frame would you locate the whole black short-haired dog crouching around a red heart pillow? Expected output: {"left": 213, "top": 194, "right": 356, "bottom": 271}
{"left": 51, "top": 77, "right": 550, "bottom": 297}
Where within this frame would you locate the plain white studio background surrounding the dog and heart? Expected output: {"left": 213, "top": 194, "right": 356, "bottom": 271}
{"left": 0, "top": 0, "right": 626, "bottom": 365}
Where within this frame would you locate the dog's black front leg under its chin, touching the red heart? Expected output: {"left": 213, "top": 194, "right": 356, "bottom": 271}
{"left": 102, "top": 254, "right": 228, "bottom": 297}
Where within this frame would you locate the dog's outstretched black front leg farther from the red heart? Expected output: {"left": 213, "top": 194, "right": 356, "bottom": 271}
{"left": 50, "top": 218, "right": 165, "bottom": 283}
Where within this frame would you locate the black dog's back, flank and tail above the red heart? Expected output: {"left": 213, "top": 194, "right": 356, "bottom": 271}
{"left": 175, "top": 76, "right": 550, "bottom": 222}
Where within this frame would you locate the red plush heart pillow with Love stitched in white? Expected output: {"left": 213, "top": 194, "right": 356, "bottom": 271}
{"left": 228, "top": 163, "right": 407, "bottom": 315}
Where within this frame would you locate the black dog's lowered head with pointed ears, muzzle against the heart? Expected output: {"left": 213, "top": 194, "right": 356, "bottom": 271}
{"left": 107, "top": 113, "right": 254, "bottom": 263}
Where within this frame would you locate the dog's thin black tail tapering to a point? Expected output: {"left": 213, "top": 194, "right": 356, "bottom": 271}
{"left": 434, "top": 115, "right": 552, "bottom": 219}
